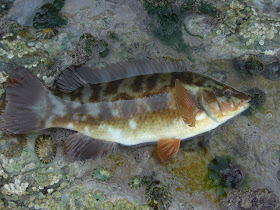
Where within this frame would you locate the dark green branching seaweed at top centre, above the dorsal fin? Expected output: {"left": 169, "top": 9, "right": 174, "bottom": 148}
{"left": 143, "top": 0, "right": 218, "bottom": 60}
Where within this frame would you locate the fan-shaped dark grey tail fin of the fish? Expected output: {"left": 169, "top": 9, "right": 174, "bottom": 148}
{"left": 0, "top": 67, "right": 49, "bottom": 134}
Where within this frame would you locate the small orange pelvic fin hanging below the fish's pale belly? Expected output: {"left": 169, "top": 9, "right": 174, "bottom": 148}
{"left": 157, "top": 139, "right": 180, "bottom": 163}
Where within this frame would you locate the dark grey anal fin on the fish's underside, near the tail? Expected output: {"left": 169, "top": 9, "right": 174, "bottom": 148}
{"left": 63, "top": 133, "right": 116, "bottom": 160}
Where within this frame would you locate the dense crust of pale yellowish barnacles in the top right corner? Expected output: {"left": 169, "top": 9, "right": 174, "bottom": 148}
{"left": 219, "top": 1, "right": 280, "bottom": 52}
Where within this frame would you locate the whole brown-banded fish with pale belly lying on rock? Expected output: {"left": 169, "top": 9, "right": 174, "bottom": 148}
{"left": 0, "top": 59, "right": 251, "bottom": 163}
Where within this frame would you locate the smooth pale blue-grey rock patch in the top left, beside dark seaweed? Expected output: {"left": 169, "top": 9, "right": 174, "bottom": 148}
{"left": 8, "top": 0, "right": 53, "bottom": 26}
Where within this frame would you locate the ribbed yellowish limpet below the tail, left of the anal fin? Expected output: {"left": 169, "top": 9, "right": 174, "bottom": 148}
{"left": 35, "top": 135, "right": 56, "bottom": 163}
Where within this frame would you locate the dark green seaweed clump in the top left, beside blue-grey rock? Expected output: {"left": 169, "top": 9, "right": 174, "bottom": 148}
{"left": 33, "top": 0, "right": 67, "bottom": 29}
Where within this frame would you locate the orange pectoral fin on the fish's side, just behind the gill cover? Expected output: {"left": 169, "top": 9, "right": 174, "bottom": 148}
{"left": 175, "top": 79, "right": 201, "bottom": 127}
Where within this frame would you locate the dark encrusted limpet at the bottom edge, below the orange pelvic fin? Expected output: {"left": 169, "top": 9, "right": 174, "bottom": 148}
{"left": 146, "top": 180, "right": 172, "bottom": 210}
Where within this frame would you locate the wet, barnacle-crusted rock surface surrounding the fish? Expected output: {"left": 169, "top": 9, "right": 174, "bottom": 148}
{"left": 0, "top": 0, "right": 280, "bottom": 209}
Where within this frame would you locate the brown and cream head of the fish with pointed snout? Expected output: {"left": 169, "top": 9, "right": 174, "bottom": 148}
{"left": 199, "top": 83, "right": 251, "bottom": 122}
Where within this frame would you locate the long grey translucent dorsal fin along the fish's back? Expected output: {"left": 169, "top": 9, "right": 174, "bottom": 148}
{"left": 56, "top": 58, "right": 186, "bottom": 93}
